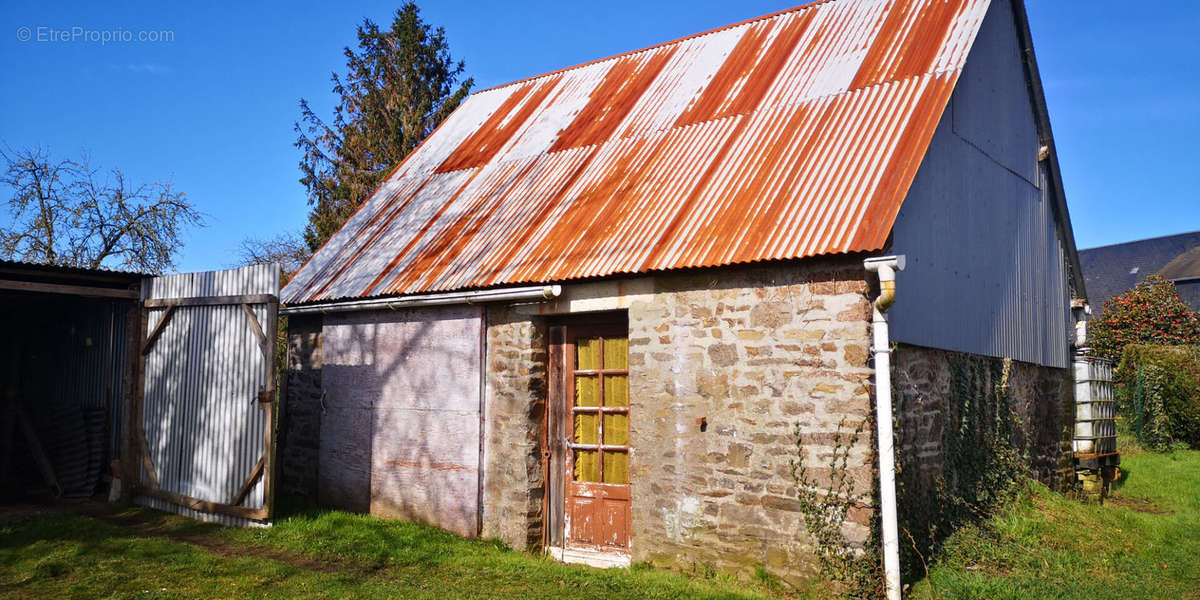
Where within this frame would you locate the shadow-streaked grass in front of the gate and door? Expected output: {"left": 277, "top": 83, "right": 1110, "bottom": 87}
{"left": 0, "top": 509, "right": 772, "bottom": 600}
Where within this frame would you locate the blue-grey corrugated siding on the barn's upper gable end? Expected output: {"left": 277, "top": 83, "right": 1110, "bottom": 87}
{"left": 889, "top": 1, "right": 1072, "bottom": 368}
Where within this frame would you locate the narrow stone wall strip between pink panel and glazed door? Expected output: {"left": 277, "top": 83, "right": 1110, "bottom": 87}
{"left": 482, "top": 306, "right": 547, "bottom": 550}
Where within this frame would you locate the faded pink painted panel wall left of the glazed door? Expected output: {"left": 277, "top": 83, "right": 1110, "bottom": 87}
{"left": 318, "top": 306, "right": 482, "bottom": 536}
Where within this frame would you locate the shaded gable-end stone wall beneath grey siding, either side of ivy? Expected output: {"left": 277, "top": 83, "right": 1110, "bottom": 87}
{"left": 892, "top": 344, "right": 1074, "bottom": 488}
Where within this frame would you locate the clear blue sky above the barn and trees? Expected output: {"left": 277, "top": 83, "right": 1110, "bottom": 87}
{"left": 0, "top": 0, "right": 1200, "bottom": 271}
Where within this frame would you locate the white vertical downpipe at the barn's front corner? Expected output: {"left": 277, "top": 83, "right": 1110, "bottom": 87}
{"left": 863, "top": 254, "right": 905, "bottom": 600}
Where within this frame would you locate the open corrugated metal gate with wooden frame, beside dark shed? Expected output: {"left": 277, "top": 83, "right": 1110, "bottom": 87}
{"left": 130, "top": 265, "right": 280, "bottom": 524}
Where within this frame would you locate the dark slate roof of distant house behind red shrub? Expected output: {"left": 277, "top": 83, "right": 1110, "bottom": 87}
{"left": 1079, "top": 232, "right": 1200, "bottom": 313}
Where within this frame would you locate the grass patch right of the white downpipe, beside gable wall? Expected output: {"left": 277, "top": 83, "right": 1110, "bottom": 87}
{"left": 908, "top": 449, "right": 1200, "bottom": 600}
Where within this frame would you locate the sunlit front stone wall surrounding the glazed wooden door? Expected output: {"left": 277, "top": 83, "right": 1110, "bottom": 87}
{"left": 484, "top": 259, "right": 872, "bottom": 581}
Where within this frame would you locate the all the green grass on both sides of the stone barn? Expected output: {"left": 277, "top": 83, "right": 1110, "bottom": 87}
{"left": 0, "top": 451, "right": 1200, "bottom": 600}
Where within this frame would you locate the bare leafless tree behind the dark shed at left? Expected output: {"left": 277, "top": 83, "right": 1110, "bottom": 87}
{"left": 0, "top": 148, "right": 203, "bottom": 272}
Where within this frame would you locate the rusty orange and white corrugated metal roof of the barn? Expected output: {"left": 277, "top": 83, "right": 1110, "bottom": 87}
{"left": 283, "top": 0, "right": 989, "bottom": 304}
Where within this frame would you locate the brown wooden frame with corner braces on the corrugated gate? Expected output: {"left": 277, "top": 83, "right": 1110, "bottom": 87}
{"left": 121, "top": 294, "right": 280, "bottom": 521}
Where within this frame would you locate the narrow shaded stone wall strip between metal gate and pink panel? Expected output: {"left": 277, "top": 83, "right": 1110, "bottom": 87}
{"left": 275, "top": 316, "right": 322, "bottom": 500}
